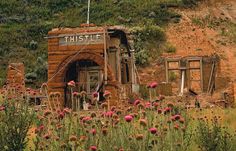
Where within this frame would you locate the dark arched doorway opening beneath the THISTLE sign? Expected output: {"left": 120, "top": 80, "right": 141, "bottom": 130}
{"left": 65, "top": 60, "right": 103, "bottom": 107}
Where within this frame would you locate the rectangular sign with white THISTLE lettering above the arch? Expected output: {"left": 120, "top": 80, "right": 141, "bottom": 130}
{"left": 59, "top": 33, "right": 104, "bottom": 45}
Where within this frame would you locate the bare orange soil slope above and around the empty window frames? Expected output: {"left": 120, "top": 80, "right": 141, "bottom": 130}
{"left": 139, "top": 0, "right": 236, "bottom": 101}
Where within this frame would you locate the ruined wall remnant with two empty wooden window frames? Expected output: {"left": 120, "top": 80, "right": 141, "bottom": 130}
{"left": 165, "top": 54, "right": 219, "bottom": 95}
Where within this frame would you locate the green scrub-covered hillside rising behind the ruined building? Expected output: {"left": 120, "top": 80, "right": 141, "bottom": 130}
{"left": 0, "top": 0, "right": 201, "bottom": 85}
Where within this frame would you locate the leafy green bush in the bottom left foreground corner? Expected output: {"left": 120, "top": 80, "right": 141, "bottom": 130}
{"left": 0, "top": 100, "right": 34, "bottom": 151}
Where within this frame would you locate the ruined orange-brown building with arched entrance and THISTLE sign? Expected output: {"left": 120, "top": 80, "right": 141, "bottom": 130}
{"left": 48, "top": 26, "right": 137, "bottom": 106}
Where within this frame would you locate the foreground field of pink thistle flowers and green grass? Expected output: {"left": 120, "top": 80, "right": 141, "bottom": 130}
{"left": 0, "top": 86, "right": 236, "bottom": 151}
